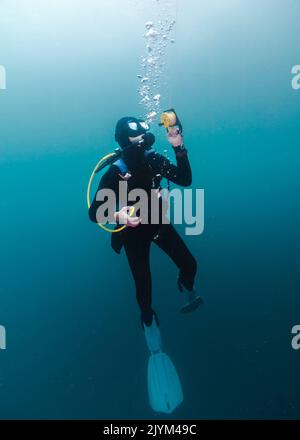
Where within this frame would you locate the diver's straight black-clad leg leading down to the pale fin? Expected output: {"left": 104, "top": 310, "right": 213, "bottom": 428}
{"left": 124, "top": 229, "right": 154, "bottom": 325}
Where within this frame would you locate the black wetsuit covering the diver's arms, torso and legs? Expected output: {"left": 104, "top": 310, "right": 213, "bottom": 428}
{"left": 89, "top": 148, "right": 197, "bottom": 325}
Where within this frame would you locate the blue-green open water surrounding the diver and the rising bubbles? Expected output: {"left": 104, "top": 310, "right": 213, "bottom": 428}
{"left": 0, "top": 0, "right": 300, "bottom": 420}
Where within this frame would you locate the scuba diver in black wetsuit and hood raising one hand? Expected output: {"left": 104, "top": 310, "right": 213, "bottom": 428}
{"left": 89, "top": 117, "right": 202, "bottom": 412}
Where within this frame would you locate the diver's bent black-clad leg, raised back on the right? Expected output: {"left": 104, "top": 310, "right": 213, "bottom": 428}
{"left": 153, "top": 224, "right": 197, "bottom": 292}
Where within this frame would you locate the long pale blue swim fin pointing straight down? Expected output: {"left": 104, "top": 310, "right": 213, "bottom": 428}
{"left": 144, "top": 319, "right": 183, "bottom": 414}
